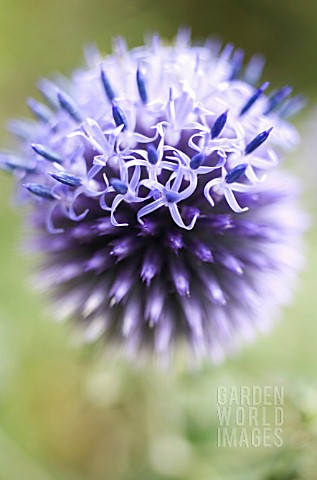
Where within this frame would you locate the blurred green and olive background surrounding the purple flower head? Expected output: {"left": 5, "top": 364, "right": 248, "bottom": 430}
{"left": 0, "top": 0, "right": 317, "bottom": 480}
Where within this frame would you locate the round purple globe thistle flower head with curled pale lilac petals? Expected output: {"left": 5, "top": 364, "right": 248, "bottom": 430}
{"left": 1, "top": 33, "right": 304, "bottom": 360}
